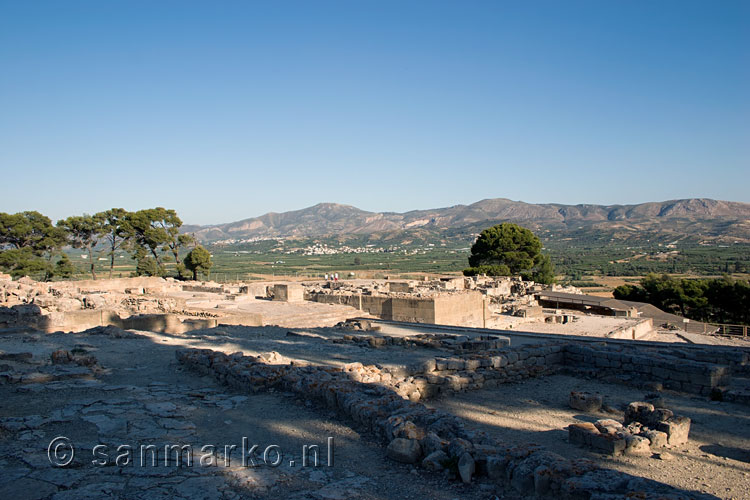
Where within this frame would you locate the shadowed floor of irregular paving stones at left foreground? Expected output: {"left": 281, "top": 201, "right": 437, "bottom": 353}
{"left": 0, "top": 329, "right": 512, "bottom": 500}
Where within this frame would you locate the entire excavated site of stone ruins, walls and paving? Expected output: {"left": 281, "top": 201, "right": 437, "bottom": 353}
{"left": 0, "top": 277, "right": 750, "bottom": 500}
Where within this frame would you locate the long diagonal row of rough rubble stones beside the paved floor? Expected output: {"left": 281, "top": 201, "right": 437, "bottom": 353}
{"left": 176, "top": 349, "right": 716, "bottom": 499}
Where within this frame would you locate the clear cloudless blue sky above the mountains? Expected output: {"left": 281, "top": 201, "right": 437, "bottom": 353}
{"left": 0, "top": 0, "right": 750, "bottom": 224}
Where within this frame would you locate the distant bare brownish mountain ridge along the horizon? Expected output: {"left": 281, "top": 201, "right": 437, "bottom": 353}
{"left": 183, "top": 198, "right": 750, "bottom": 243}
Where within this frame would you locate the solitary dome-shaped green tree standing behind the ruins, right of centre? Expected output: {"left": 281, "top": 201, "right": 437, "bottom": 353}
{"left": 464, "top": 222, "right": 555, "bottom": 283}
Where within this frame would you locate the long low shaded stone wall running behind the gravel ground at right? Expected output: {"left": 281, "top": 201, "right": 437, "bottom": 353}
{"left": 324, "top": 333, "right": 750, "bottom": 403}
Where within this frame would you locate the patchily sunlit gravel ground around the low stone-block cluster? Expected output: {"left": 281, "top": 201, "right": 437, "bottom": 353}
{"left": 427, "top": 375, "right": 750, "bottom": 499}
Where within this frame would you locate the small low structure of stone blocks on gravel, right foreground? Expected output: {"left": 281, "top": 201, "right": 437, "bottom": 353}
{"left": 568, "top": 402, "right": 690, "bottom": 456}
